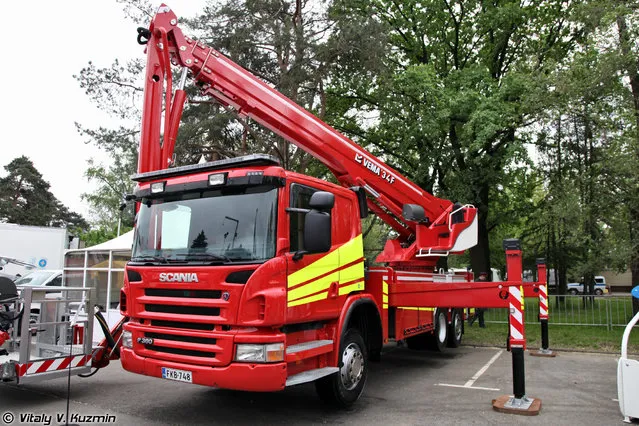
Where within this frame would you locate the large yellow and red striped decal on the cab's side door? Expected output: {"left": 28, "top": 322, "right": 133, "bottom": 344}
{"left": 287, "top": 234, "right": 364, "bottom": 308}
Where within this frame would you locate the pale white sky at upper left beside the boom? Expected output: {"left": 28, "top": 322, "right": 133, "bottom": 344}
{"left": 0, "top": 0, "right": 206, "bottom": 223}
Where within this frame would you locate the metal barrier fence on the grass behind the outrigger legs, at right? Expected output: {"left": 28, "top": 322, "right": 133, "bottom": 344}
{"left": 484, "top": 295, "right": 633, "bottom": 330}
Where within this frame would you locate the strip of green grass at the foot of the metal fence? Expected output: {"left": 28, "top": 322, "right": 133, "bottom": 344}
{"left": 463, "top": 322, "right": 639, "bottom": 354}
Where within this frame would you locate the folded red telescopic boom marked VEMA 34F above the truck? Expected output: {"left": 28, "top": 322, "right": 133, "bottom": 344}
{"left": 138, "top": 5, "right": 477, "bottom": 263}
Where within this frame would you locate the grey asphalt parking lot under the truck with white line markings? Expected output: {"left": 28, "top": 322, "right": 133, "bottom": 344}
{"left": 0, "top": 347, "right": 624, "bottom": 425}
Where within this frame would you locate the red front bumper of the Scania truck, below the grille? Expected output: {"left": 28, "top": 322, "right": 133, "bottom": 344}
{"left": 120, "top": 348, "right": 286, "bottom": 392}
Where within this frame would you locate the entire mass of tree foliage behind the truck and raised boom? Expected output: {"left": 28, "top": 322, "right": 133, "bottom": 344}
{"left": 76, "top": 0, "right": 639, "bottom": 290}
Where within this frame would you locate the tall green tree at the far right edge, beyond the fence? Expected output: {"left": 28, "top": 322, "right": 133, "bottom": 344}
{"left": 531, "top": 1, "right": 639, "bottom": 292}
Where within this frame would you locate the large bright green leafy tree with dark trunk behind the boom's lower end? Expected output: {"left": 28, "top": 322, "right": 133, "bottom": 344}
{"left": 324, "top": 0, "right": 581, "bottom": 272}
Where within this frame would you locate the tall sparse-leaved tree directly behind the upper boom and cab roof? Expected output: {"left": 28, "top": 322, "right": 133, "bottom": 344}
{"left": 75, "top": 0, "right": 342, "bottom": 227}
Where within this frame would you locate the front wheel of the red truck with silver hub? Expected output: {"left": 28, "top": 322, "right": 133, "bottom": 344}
{"left": 315, "top": 328, "right": 368, "bottom": 408}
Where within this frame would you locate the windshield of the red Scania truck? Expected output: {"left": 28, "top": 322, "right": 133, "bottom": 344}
{"left": 131, "top": 186, "right": 277, "bottom": 264}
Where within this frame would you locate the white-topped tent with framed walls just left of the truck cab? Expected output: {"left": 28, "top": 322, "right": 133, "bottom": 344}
{"left": 62, "top": 231, "right": 133, "bottom": 342}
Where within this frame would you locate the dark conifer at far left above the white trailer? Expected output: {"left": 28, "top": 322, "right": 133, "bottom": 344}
{"left": 0, "top": 156, "right": 88, "bottom": 230}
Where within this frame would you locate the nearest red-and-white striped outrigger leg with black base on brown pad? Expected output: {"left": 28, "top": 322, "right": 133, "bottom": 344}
{"left": 493, "top": 239, "right": 541, "bottom": 416}
